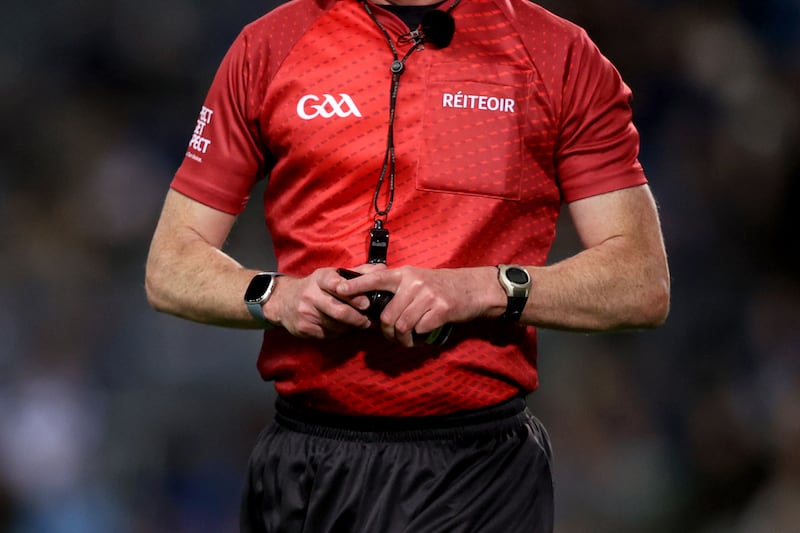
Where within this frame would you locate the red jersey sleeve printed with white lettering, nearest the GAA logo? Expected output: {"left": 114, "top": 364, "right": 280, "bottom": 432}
{"left": 171, "top": 31, "right": 266, "bottom": 215}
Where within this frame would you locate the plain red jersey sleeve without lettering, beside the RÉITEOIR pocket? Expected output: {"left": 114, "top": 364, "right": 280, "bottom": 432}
{"left": 556, "top": 31, "right": 647, "bottom": 203}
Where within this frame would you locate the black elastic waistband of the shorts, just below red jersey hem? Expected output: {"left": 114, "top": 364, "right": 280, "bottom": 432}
{"left": 275, "top": 396, "right": 528, "bottom": 442}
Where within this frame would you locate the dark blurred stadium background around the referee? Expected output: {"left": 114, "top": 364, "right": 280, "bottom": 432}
{"left": 0, "top": 0, "right": 800, "bottom": 533}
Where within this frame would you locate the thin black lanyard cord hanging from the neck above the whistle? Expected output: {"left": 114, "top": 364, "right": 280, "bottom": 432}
{"left": 363, "top": 0, "right": 421, "bottom": 219}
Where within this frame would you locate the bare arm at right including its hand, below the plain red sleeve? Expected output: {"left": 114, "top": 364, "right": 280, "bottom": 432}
{"left": 337, "top": 186, "right": 669, "bottom": 346}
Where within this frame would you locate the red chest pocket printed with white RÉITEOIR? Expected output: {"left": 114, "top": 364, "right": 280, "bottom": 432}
{"left": 416, "top": 62, "right": 532, "bottom": 200}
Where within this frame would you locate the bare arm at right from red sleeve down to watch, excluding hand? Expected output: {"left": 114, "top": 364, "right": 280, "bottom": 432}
{"left": 523, "top": 186, "right": 670, "bottom": 331}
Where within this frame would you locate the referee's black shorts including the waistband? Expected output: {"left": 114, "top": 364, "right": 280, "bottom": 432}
{"left": 241, "top": 397, "right": 553, "bottom": 533}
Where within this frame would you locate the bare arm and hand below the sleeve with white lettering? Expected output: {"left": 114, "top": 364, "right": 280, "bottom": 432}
{"left": 145, "top": 190, "right": 369, "bottom": 332}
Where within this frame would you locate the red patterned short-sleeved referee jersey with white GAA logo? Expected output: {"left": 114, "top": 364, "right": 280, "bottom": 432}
{"left": 172, "top": 0, "right": 646, "bottom": 416}
